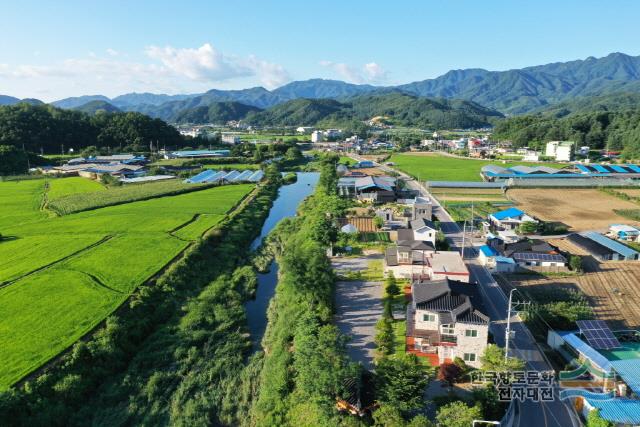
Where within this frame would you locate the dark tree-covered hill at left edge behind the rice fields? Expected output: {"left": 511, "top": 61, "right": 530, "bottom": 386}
{"left": 0, "top": 103, "right": 183, "bottom": 153}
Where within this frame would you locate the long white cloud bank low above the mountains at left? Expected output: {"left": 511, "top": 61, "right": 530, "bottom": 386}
{"left": 0, "top": 43, "right": 291, "bottom": 100}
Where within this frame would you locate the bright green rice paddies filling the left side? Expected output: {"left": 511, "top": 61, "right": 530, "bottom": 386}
{"left": 0, "top": 178, "right": 254, "bottom": 389}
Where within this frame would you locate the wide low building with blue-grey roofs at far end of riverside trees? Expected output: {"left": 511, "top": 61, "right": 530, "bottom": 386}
{"left": 338, "top": 175, "right": 396, "bottom": 203}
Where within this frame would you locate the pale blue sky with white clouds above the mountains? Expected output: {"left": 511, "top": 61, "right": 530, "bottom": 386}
{"left": 0, "top": 0, "right": 640, "bottom": 101}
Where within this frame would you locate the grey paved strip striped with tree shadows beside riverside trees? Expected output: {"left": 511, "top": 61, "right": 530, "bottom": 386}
{"left": 331, "top": 255, "right": 382, "bottom": 369}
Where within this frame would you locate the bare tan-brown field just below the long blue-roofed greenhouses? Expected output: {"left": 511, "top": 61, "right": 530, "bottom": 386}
{"left": 507, "top": 188, "right": 639, "bottom": 231}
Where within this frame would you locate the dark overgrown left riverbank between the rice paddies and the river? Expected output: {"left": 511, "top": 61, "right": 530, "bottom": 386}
{"left": 0, "top": 170, "right": 281, "bottom": 426}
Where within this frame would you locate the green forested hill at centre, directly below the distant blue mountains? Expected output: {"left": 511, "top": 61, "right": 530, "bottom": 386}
{"left": 245, "top": 93, "right": 502, "bottom": 129}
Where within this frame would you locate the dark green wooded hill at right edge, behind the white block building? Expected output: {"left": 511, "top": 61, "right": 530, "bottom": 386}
{"left": 493, "top": 109, "right": 640, "bottom": 159}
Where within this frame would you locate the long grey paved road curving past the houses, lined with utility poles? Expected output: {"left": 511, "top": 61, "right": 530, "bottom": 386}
{"left": 358, "top": 155, "right": 582, "bottom": 427}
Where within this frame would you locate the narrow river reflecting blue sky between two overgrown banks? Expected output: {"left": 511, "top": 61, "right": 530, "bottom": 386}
{"left": 246, "top": 172, "right": 320, "bottom": 349}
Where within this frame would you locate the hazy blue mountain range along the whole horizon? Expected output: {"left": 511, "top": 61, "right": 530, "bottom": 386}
{"left": 0, "top": 53, "right": 640, "bottom": 121}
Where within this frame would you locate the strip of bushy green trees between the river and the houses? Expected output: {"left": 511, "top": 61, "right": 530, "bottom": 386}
{"left": 248, "top": 162, "right": 358, "bottom": 426}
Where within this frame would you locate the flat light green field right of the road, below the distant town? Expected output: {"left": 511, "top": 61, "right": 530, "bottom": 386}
{"left": 389, "top": 153, "right": 565, "bottom": 181}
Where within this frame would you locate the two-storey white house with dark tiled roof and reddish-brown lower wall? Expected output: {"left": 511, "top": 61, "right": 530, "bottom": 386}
{"left": 406, "top": 279, "right": 489, "bottom": 368}
